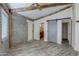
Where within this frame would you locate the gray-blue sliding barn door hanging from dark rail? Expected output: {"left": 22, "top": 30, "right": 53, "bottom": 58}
{"left": 48, "top": 20, "right": 57, "bottom": 42}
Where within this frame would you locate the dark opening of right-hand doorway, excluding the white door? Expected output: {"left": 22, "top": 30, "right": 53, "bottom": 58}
{"left": 62, "top": 22, "right": 69, "bottom": 44}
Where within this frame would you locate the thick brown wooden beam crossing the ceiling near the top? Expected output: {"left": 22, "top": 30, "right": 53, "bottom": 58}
{"left": 12, "top": 3, "right": 70, "bottom": 12}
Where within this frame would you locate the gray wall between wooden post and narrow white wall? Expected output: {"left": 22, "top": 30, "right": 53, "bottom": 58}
{"left": 12, "top": 14, "right": 28, "bottom": 46}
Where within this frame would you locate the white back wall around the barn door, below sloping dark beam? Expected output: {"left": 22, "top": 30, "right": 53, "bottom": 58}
{"left": 34, "top": 8, "right": 72, "bottom": 44}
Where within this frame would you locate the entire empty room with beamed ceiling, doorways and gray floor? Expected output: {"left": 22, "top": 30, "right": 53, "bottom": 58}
{"left": 0, "top": 3, "right": 79, "bottom": 56}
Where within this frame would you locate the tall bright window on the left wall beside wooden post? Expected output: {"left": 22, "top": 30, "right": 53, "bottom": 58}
{"left": 1, "top": 10, "right": 8, "bottom": 39}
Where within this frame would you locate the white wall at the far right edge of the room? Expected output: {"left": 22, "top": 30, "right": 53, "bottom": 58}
{"left": 73, "top": 3, "right": 79, "bottom": 51}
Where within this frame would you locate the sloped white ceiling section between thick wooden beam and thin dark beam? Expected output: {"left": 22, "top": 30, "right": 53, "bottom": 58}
{"left": 18, "top": 5, "right": 67, "bottom": 19}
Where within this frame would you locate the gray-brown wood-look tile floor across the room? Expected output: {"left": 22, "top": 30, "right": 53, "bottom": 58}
{"left": 0, "top": 41, "right": 79, "bottom": 56}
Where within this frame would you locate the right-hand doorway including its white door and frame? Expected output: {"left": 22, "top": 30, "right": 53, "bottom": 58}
{"left": 62, "top": 19, "right": 72, "bottom": 45}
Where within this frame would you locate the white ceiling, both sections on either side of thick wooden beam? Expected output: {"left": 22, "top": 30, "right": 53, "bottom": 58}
{"left": 9, "top": 3, "right": 68, "bottom": 19}
